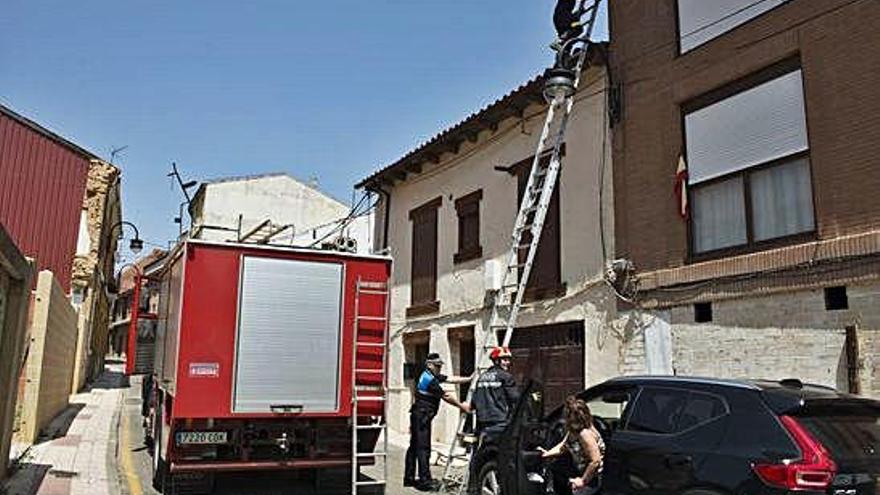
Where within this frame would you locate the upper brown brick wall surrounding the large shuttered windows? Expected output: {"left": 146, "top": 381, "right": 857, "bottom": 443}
{"left": 610, "top": 0, "right": 880, "bottom": 271}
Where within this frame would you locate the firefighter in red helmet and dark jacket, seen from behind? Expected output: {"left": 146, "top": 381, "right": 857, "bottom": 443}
{"left": 471, "top": 347, "right": 519, "bottom": 437}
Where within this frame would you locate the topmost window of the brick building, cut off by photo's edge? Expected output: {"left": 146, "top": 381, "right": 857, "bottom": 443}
{"left": 678, "top": 0, "right": 787, "bottom": 53}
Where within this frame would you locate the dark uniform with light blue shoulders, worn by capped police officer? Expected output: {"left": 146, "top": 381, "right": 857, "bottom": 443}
{"left": 403, "top": 370, "right": 446, "bottom": 483}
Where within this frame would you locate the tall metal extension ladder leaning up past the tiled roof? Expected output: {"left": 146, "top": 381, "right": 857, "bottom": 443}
{"left": 443, "top": 0, "right": 601, "bottom": 494}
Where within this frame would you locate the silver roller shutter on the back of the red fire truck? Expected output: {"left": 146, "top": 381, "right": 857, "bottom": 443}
{"left": 233, "top": 256, "right": 343, "bottom": 413}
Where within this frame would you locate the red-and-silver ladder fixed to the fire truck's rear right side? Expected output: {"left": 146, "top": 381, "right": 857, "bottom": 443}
{"left": 351, "top": 278, "right": 391, "bottom": 495}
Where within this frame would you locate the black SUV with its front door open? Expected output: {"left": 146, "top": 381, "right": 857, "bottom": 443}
{"left": 469, "top": 377, "right": 880, "bottom": 495}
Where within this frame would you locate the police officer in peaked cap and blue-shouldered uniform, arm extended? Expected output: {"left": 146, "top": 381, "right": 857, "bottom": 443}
{"left": 403, "top": 352, "right": 470, "bottom": 491}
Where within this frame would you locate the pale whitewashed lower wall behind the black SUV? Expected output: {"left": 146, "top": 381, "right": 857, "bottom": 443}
{"left": 618, "top": 281, "right": 880, "bottom": 397}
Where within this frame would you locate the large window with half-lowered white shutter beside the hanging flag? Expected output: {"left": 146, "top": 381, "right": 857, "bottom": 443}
{"left": 684, "top": 62, "right": 815, "bottom": 254}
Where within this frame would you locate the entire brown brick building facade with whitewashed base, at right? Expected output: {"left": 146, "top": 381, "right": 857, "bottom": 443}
{"left": 610, "top": 0, "right": 880, "bottom": 395}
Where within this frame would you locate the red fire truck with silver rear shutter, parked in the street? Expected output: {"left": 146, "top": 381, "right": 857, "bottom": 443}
{"left": 146, "top": 240, "right": 391, "bottom": 493}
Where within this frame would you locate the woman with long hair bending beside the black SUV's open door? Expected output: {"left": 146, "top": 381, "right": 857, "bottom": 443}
{"left": 538, "top": 395, "right": 605, "bottom": 495}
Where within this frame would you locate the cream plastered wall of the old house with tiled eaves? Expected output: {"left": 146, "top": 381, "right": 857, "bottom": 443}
{"left": 375, "top": 69, "right": 619, "bottom": 442}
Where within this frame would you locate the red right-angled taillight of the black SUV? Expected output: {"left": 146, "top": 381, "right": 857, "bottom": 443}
{"left": 752, "top": 416, "right": 837, "bottom": 490}
